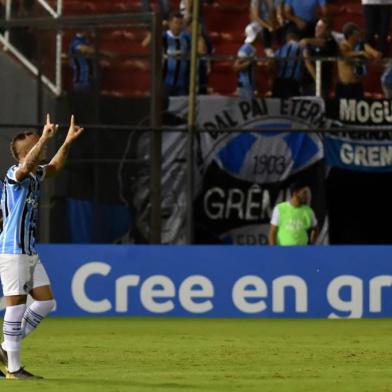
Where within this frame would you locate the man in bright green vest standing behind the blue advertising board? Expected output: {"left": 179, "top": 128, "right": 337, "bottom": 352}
{"left": 268, "top": 183, "right": 319, "bottom": 246}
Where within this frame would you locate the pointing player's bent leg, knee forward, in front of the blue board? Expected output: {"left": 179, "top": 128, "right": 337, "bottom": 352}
{"left": 22, "top": 256, "right": 56, "bottom": 337}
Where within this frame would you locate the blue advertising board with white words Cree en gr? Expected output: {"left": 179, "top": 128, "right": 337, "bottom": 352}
{"left": 2, "top": 245, "right": 392, "bottom": 318}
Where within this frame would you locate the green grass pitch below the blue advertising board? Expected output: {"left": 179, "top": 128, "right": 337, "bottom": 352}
{"left": 0, "top": 318, "right": 392, "bottom": 392}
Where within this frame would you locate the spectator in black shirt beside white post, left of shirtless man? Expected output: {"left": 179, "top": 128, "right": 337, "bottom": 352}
{"left": 300, "top": 17, "right": 339, "bottom": 98}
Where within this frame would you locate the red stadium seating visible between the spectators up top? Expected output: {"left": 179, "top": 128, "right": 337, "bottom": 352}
{"left": 59, "top": 0, "right": 383, "bottom": 98}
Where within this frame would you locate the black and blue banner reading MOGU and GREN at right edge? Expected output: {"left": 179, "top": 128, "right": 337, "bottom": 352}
{"left": 324, "top": 99, "right": 392, "bottom": 172}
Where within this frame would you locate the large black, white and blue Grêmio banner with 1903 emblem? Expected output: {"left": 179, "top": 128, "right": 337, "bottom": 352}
{"left": 168, "top": 97, "right": 327, "bottom": 244}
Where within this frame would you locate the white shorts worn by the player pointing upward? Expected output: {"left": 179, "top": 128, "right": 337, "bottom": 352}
{"left": 0, "top": 254, "right": 50, "bottom": 297}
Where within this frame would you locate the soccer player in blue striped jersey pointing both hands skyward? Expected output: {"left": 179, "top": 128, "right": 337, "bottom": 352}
{"left": 0, "top": 115, "right": 83, "bottom": 379}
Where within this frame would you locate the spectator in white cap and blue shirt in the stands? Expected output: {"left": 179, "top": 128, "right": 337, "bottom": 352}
{"left": 233, "top": 23, "right": 262, "bottom": 98}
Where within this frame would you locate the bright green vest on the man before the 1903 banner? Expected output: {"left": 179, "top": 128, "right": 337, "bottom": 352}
{"left": 277, "top": 201, "right": 313, "bottom": 246}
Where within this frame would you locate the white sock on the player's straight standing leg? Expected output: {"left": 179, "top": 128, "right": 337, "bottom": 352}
{"left": 2, "top": 304, "right": 26, "bottom": 373}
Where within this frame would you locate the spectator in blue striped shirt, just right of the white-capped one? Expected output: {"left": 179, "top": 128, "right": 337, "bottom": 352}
{"left": 270, "top": 26, "right": 304, "bottom": 98}
